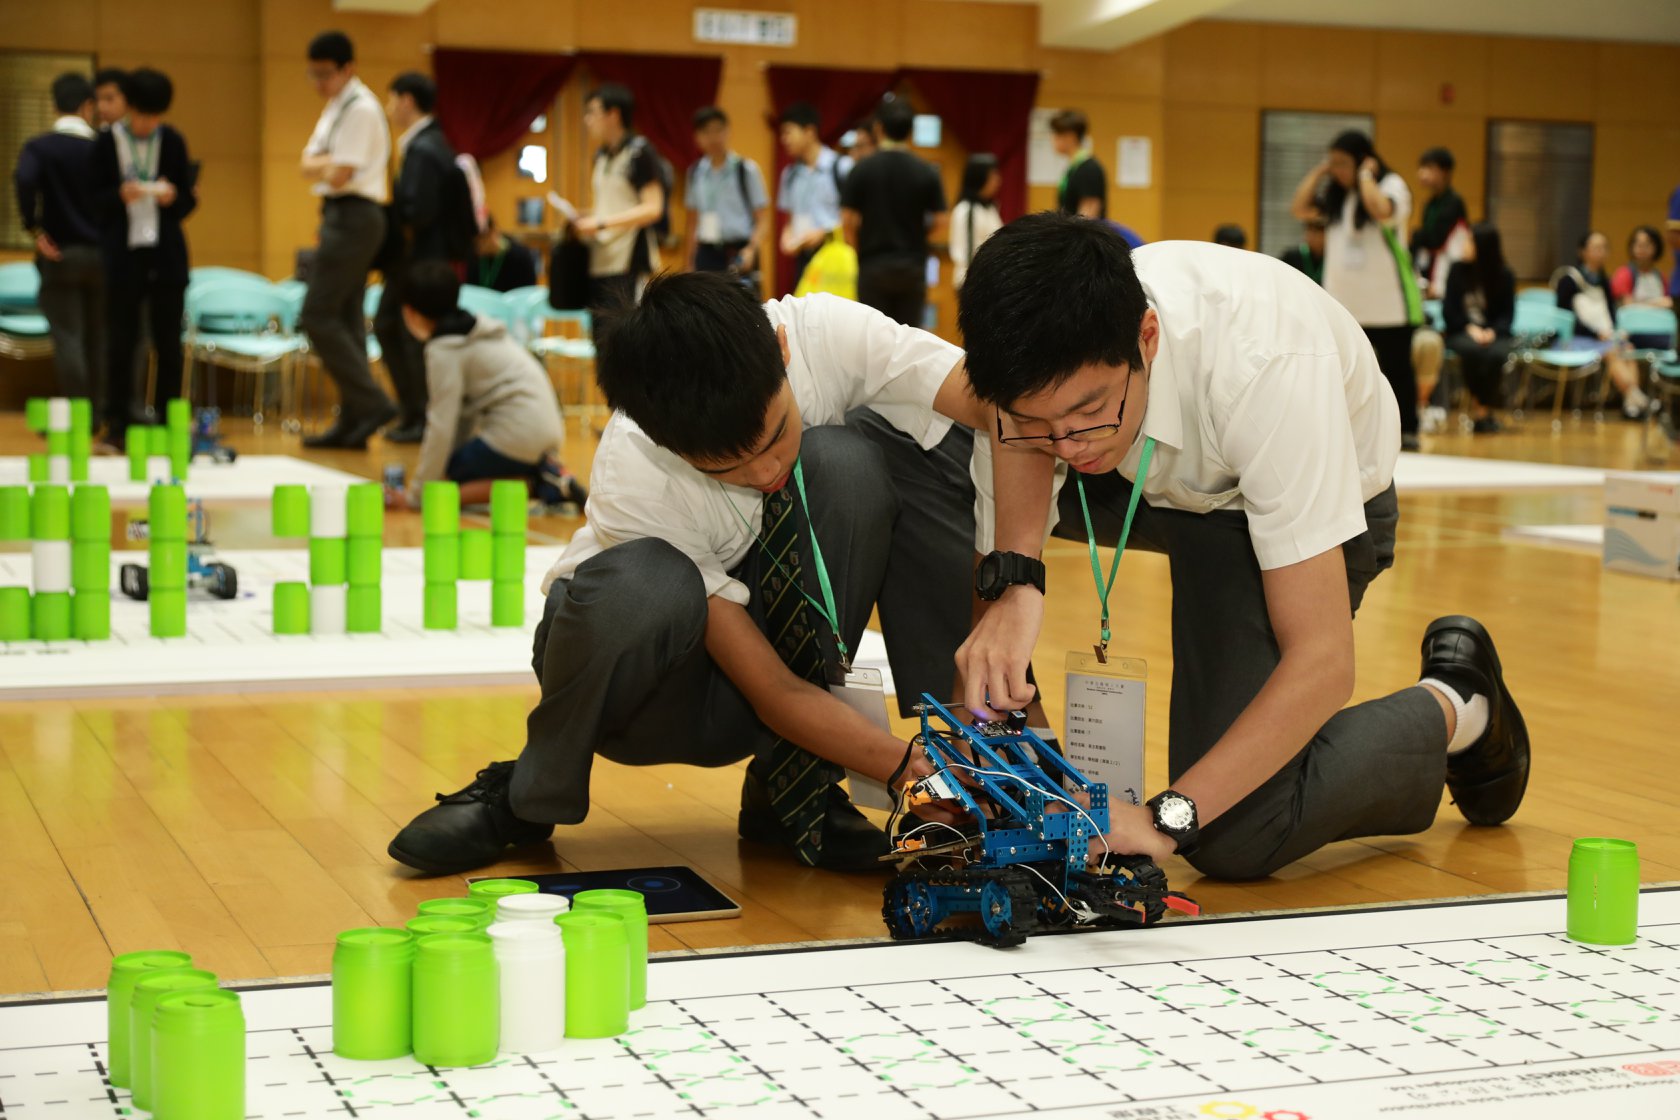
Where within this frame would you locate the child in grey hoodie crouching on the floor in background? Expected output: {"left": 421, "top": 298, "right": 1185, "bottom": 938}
{"left": 403, "top": 260, "right": 588, "bottom": 507}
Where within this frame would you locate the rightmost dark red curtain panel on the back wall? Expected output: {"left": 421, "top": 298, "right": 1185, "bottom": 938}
{"left": 900, "top": 67, "right": 1038, "bottom": 222}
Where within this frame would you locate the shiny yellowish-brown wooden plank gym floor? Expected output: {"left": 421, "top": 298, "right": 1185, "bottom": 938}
{"left": 0, "top": 415, "right": 1680, "bottom": 992}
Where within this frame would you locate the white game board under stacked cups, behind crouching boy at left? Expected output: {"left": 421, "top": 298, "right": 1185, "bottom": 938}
{"left": 0, "top": 546, "right": 892, "bottom": 695}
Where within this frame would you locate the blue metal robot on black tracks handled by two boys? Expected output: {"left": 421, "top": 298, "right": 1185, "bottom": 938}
{"left": 880, "top": 693, "right": 1200, "bottom": 947}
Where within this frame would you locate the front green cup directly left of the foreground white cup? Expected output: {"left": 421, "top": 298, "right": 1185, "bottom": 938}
{"left": 415, "top": 940, "right": 502, "bottom": 1066}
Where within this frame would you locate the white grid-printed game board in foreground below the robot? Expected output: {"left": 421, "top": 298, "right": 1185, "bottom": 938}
{"left": 0, "top": 890, "right": 1680, "bottom": 1120}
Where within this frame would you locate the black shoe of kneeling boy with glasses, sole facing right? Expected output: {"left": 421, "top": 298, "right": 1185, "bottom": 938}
{"left": 1423, "top": 615, "right": 1529, "bottom": 824}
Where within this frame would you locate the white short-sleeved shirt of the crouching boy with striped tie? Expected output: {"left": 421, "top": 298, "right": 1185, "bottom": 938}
{"left": 543, "top": 294, "right": 963, "bottom": 606}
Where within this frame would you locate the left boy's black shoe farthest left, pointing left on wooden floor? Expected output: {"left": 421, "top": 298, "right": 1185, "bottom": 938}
{"left": 386, "top": 762, "right": 554, "bottom": 875}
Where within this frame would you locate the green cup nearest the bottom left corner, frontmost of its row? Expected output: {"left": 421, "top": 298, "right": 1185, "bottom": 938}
{"left": 151, "top": 989, "right": 245, "bottom": 1120}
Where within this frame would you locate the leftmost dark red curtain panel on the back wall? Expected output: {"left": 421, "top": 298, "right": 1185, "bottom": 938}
{"left": 432, "top": 47, "right": 578, "bottom": 161}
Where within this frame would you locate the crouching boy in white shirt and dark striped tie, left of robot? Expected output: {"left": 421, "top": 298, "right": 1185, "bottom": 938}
{"left": 390, "top": 272, "right": 990, "bottom": 873}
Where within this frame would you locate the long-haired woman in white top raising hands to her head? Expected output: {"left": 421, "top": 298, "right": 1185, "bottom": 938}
{"left": 1292, "top": 129, "right": 1423, "bottom": 452}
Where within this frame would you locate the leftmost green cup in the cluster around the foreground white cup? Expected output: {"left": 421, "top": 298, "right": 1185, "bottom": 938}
{"left": 333, "top": 929, "right": 415, "bottom": 1061}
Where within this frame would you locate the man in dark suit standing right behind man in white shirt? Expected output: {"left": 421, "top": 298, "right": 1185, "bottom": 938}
{"left": 373, "top": 71, "right": 474, "bottom": 443}
